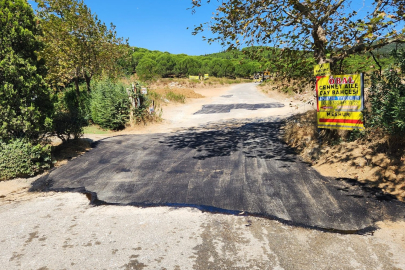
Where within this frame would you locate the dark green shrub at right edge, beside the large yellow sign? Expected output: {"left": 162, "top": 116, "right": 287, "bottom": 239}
{"left": 365, "top": 50, "right": 405, "bottom": 136}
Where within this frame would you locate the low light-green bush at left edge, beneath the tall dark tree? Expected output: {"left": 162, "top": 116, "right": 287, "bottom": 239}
{"left": 0, "top": 139, "right": 52, "bottom": 180}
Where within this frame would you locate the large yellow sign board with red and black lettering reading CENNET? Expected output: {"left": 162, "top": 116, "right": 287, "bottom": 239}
{"left": 316, "top": 74, "right": 364, "bottom": 130}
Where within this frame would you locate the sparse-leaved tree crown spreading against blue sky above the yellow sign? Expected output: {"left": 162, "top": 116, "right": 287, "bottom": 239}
{"left": 192, "top": 0, "right": 405, "bottom": 63}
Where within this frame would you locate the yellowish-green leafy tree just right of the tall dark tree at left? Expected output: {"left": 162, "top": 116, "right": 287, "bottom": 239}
{"left": 36, "top": 0, "right": 127, "bottom": 94}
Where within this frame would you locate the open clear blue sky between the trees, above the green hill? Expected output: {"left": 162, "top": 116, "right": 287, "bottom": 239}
{"left": 28, "top": 0, "right": 224, "bottom": 55}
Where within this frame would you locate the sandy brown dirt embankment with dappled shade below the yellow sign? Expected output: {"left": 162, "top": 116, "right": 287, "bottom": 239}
{"left": 284, "top": 110, "right": 405, "bottom": 201}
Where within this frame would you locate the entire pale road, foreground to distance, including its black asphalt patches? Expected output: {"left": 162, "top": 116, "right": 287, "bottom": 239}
{"left": 0, "top": 84, "right": 405, "bottom": 269}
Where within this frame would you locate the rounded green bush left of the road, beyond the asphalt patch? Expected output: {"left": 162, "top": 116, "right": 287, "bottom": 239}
{"left": 90, "top": 79, "right": 130, "bottom": 130}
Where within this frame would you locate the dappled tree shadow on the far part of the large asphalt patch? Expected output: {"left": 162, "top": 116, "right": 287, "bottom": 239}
{"left": 159, "top": 121, "right": 297, "bottom": 162}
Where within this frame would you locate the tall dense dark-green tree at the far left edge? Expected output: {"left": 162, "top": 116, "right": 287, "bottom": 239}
{"left": 0, "top": 0, "right": 53, "bottom": 140}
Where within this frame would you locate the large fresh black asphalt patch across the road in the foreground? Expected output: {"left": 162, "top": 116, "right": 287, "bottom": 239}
{"left": 32, "top": 119, "right": 405, "bottom": 233}
